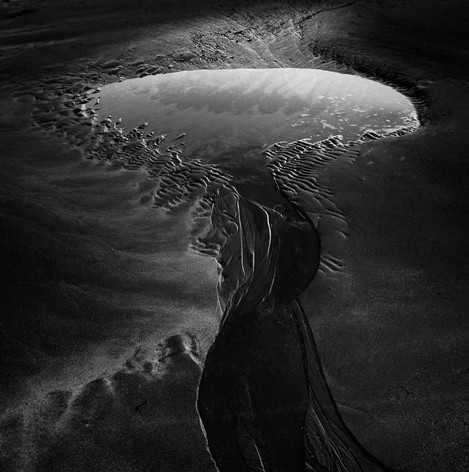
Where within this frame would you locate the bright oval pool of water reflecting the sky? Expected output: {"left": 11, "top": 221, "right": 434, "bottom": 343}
{"left": 93, "top": 69, "right": 415, "bottom": 161}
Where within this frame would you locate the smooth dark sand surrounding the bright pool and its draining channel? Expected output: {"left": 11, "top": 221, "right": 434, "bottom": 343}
{"left": 0, "top": 0, "right": 469, "bottom": 472}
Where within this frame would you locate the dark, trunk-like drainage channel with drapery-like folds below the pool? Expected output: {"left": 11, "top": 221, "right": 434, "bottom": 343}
{"left": 198, "top": 184, "right": 384, "bottom": 471}
